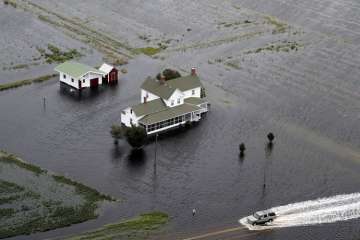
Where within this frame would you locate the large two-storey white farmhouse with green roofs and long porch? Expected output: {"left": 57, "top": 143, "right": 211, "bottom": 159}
{"left": 121, "top": 68, "right": 209, "bottom": 134}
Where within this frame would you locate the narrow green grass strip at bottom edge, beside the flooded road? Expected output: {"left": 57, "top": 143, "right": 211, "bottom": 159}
{"left": 67, "top": 212, "right": 169, "bottom": 240}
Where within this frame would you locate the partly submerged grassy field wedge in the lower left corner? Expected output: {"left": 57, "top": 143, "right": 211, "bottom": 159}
{"left": 0, "top": 152, "right": 112, "bottom": 238}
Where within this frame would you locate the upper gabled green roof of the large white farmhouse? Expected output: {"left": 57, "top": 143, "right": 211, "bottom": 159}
{"left": 141, "top": 75, "right": 202, "bottom": 99}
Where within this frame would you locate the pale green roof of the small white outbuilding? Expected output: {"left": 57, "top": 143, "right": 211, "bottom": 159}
{"left": 55, "top": 61, "right": 105, "bottom": 78}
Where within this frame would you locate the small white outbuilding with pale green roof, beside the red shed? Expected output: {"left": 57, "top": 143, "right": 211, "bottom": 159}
{"left": 55, "top": 61, "right": 106, "bottom": 90}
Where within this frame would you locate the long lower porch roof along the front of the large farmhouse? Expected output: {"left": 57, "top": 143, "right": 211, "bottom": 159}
{"left": 139, "top": 103, "right": 201, "bottom": 125}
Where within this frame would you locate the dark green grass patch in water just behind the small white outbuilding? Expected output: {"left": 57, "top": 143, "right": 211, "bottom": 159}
{"left": 37, "top": 44, "right": 82, "bottom": 64}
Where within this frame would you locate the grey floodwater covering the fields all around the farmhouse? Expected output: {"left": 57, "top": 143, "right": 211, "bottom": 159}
{"left": 0, "top": 0, "right": 360, "bottom": 239}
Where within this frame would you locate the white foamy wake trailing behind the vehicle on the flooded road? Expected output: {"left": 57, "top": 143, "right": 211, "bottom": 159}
{"left": 239, "top": 193, "right": 360, "bottom": 230}
